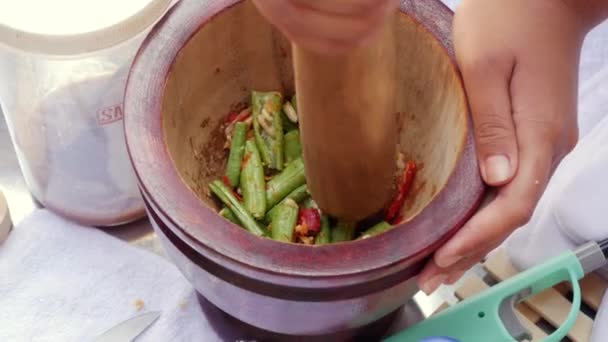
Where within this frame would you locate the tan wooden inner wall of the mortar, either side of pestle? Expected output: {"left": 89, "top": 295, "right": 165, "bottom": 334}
{"left": 162, "top": 1, "right": 467, "bottom": 231}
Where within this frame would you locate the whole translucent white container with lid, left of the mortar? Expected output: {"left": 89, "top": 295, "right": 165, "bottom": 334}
{"left": 0, "top": 0, "right": 172, "bottom": 226}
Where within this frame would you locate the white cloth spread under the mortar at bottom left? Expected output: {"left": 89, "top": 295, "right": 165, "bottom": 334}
{"left": 0, "top": 210, "right": 220, "bottom": 342}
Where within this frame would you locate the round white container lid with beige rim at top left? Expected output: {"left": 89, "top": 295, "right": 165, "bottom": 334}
{"left": 0, "top": 0, "right": 173, "bottom": 55}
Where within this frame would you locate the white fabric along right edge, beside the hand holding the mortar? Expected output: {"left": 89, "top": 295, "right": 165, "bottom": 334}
{"left": 503, "top": 23, "right": 608, "bottom": 342}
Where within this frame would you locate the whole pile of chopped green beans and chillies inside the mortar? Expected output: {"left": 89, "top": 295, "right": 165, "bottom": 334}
{"left": 216, "top": 91, "right": 406, "bottom": 245}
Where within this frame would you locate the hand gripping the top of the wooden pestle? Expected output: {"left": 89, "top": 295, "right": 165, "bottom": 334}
{"left": 253, "top": 0, "right": 398, "bottom": 54}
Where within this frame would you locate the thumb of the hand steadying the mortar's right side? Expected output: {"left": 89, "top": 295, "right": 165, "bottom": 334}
{"left": 461, "top": 59, "right": 518, "bottom": 186}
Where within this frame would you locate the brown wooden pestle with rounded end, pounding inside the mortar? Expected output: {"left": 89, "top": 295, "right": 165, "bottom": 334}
{"left": 293, "top": 14, "right": 397, "bottom": 221}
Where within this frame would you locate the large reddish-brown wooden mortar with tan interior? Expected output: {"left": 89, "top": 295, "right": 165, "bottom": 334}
{"left": 125, "top": 0, "right": 484, "bottom": 340}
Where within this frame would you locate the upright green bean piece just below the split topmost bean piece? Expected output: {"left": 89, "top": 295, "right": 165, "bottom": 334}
{"left": 241, "top": 140, "right": 266, "bottom": 219}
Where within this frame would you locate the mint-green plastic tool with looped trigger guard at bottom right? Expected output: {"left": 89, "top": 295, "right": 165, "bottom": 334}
{"left": 385, "top": 240, "right": 608, "bottom": 342}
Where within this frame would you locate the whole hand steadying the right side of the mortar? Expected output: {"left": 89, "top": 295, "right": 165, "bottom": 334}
{"left": 418, "top": 0, "right": 595, "bottom": 294}
